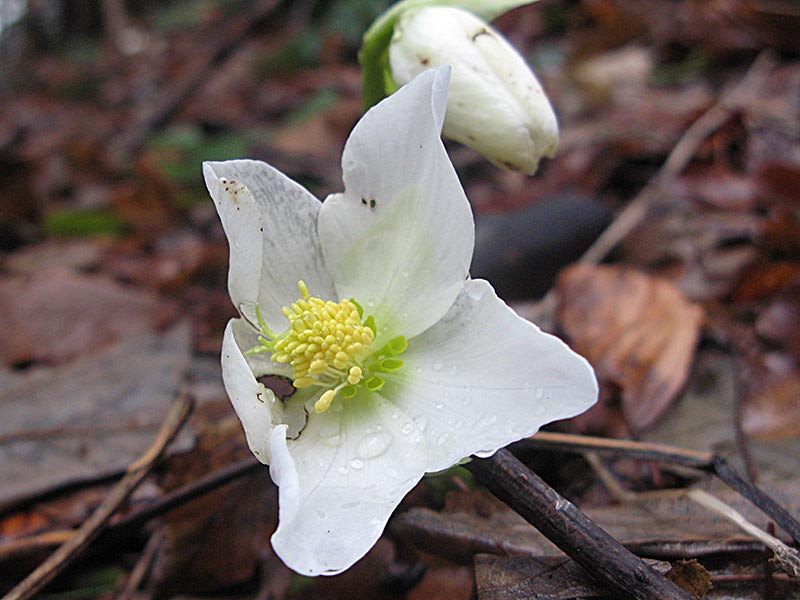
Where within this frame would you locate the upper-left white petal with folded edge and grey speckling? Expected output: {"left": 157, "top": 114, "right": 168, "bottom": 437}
{"left": 203, "top": 160, "right": 338, "bottom": 331}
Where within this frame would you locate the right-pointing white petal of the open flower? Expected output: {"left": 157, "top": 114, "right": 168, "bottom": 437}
{"left": 381, "top": 280, "right": 597, "bottom": 471}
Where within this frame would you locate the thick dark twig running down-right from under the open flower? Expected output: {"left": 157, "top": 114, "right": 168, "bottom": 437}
{"left": 465, "top": 449, "right": 692, "bottom": 600}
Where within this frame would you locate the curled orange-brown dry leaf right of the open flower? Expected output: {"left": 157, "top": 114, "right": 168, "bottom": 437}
{"left": 557, "top": 265, "right": 703, "bottom": 430}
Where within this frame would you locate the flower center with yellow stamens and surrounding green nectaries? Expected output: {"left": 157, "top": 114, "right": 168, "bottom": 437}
{"left": 245, "top": 281, "right": 408, "bottom": 413}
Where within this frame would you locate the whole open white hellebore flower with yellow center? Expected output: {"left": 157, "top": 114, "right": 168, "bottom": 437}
{"left": 203, "top": 68, "right": 597, "bottom": 575}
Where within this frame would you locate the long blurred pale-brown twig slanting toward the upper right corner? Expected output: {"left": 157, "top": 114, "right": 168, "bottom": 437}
{"left": 529, "top": 50, "right": 775, "bottom": 329}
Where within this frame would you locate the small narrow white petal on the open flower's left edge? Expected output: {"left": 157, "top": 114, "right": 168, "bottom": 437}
{"left": 222, "top": 319, "right": 283, "bottom": 464}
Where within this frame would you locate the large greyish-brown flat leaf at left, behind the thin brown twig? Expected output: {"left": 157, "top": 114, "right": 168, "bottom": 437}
{"left": 0, "top": 325, "right": 191, "bottom": 502}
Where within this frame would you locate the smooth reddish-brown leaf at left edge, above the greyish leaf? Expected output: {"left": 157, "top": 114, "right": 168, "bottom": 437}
{"left": 0, "top": 268, "right": 172, "bottom": 365}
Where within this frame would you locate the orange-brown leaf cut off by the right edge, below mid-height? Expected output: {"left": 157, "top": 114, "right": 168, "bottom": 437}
{"left": 742, "top": 371, "right": 800, "bottom": 440}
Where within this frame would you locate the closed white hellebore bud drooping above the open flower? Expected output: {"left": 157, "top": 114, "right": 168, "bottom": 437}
{"left": 389, "top": 6, "right": 558, "bottom": 175}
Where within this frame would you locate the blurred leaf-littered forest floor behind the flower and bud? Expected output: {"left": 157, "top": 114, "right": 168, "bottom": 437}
{"left": 0, "top": 0, "right": 800, "bottom": 600}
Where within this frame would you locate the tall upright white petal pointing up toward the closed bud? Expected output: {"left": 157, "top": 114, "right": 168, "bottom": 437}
{"left": 319, "top": 69, "right": 475, "bottom": 337}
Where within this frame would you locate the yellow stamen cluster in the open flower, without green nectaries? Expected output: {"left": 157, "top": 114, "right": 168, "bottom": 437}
{"left": 272, "top": 281, "right": 375, "bottom": 396}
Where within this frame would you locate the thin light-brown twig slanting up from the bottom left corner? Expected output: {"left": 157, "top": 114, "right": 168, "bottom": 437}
{"left": 3, "top": 394, "right": 193, "bottom": 600}
